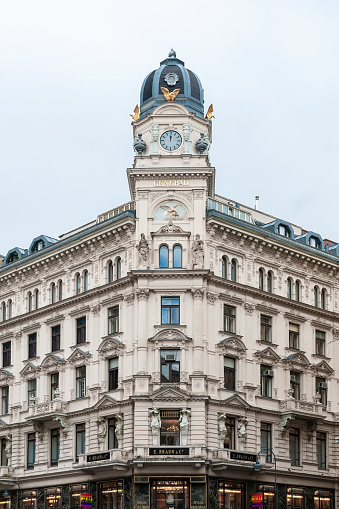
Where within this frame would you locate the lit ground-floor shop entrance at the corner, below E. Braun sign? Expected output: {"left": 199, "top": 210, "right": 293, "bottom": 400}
{"left": 151, "top": 480, "right": 189, "bottom": 509}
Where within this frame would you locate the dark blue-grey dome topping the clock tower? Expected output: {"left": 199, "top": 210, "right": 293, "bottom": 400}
{"left": 140, "top": 50, "right": 204, "bottom": 118}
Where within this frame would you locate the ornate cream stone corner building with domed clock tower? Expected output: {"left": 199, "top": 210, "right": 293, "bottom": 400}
{"left": 0, "top": 51, "right": 339, "bottom": 509}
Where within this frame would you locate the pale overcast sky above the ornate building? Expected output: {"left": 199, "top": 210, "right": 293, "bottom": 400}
{"left": 0, "top": 0, "right": 339, "bottom": 254}
